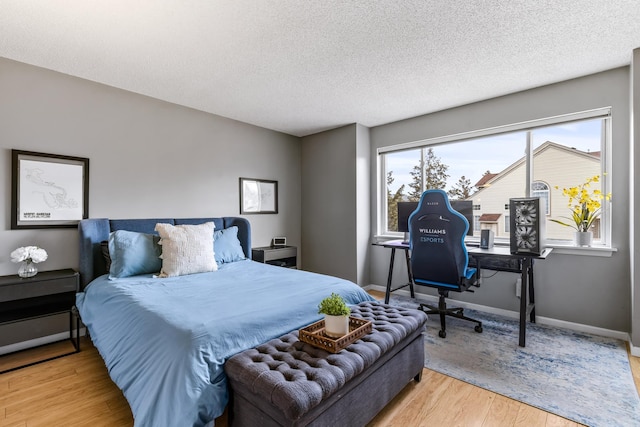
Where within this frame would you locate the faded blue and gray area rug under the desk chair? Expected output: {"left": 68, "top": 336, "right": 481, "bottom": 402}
{"left": 390, "top": 296, "right": 640, "bottom": 427}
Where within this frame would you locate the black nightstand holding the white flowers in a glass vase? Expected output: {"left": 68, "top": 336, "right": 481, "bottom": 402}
{"left": 0, "top": 268, "right": 80, "bottom": 374}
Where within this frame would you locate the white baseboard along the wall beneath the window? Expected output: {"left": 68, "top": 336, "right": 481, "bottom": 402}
{"left": 364, "top": 285, "right": 640, "bottom": 342}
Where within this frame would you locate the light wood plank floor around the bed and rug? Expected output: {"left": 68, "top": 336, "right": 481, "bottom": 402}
{"left": 0, "top": 291, "right": 640, "bottom": 427}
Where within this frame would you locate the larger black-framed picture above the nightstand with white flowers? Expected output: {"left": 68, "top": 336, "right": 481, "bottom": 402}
{"left": 11, "top": 150, "right": 89, "bottom": 230}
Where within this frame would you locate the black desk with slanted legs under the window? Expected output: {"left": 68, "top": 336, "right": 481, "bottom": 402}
{"left": 374, "top": 240, "right": 552, "bottom": 347}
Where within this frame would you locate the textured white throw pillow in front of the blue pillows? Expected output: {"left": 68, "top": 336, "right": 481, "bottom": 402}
{"left": 155, "top": 222, "right": 218, "bottom": 277}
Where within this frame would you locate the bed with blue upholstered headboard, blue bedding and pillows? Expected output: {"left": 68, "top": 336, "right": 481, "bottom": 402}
{"left": 76, "top": 217, "right": 373, "bottom": 427}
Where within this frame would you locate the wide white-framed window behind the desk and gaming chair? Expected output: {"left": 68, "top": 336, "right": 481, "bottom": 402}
{"left": 378, "top": 108, "right": 610, "bottom": 244}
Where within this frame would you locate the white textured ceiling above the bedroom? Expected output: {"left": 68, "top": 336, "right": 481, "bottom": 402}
{"left": 0, "top": 0, "right": 640, "bottom": 136}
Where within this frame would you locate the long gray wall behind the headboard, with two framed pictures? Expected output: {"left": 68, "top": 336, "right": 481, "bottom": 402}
{"left": 0, "top": 58, "right": 301, "bottom": 346}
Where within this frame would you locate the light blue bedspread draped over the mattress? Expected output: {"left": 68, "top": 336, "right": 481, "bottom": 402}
{"left": 77, "top": 260, "right": 372, "bottom": 427}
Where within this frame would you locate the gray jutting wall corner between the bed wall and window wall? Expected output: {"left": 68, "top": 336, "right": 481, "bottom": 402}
{"left": 302, "top": 124, "right": 370, "bottom": 285}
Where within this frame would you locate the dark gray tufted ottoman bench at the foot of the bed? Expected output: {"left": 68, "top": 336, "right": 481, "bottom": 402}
{"left": 225, "top": 302, "right": 427, "bottom": 426}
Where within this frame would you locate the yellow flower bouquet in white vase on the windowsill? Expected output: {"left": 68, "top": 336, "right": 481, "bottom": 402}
{"left": 551, "top": 175, "right": 611, "bottom": 231}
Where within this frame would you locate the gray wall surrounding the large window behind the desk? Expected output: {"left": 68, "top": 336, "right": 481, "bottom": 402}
{"left": 371, "top": 67, "right": 631, "bottom": 331}
